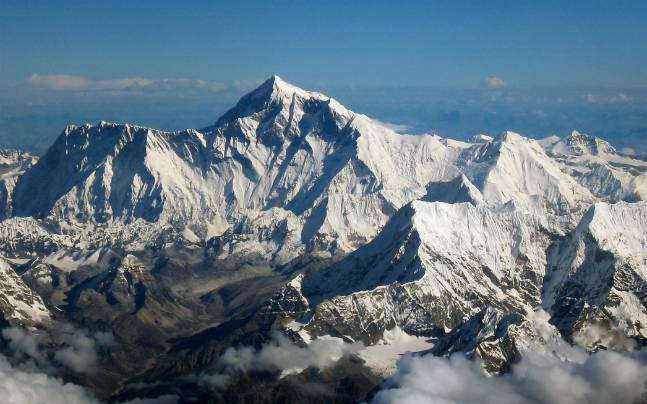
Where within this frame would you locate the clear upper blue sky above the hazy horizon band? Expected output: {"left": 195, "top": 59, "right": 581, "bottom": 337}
{"left": 0, "top": 0, "right": 647, "bottom": 87}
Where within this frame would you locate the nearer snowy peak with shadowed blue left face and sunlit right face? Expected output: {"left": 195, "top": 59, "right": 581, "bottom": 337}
{"left": 302, "top": 201, "right": 550, "bottom": 338}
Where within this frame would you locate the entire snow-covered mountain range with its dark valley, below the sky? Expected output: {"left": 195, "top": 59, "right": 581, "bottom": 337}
{"left": 0, "top": 76, "right": 647, "bottom": 402}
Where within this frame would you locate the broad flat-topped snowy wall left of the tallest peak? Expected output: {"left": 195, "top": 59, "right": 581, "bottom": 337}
{"left": 14, "top": 122, "right": 223, "bottom": 230}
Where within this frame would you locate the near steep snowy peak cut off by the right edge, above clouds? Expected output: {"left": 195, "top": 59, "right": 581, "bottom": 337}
{"left": 543, "top": 202, "right": 647, "bottom": 339}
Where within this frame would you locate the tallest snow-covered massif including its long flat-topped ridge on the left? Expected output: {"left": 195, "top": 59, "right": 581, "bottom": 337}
{"left": 13, "top": 77, "right": 440, "bottom": 249}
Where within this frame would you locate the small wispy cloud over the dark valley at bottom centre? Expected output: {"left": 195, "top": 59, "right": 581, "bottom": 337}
{"left": 199, "top": 334, "right": 364, "bottom": 388}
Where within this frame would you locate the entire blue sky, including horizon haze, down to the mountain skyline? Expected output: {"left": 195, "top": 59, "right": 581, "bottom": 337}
{"left": 0, "top": 0, "right": 647, "bottom": 153}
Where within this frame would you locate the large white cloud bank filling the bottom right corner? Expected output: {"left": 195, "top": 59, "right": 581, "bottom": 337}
{"left": 373, "top": 348, "right": 647, "bottom": 404}
